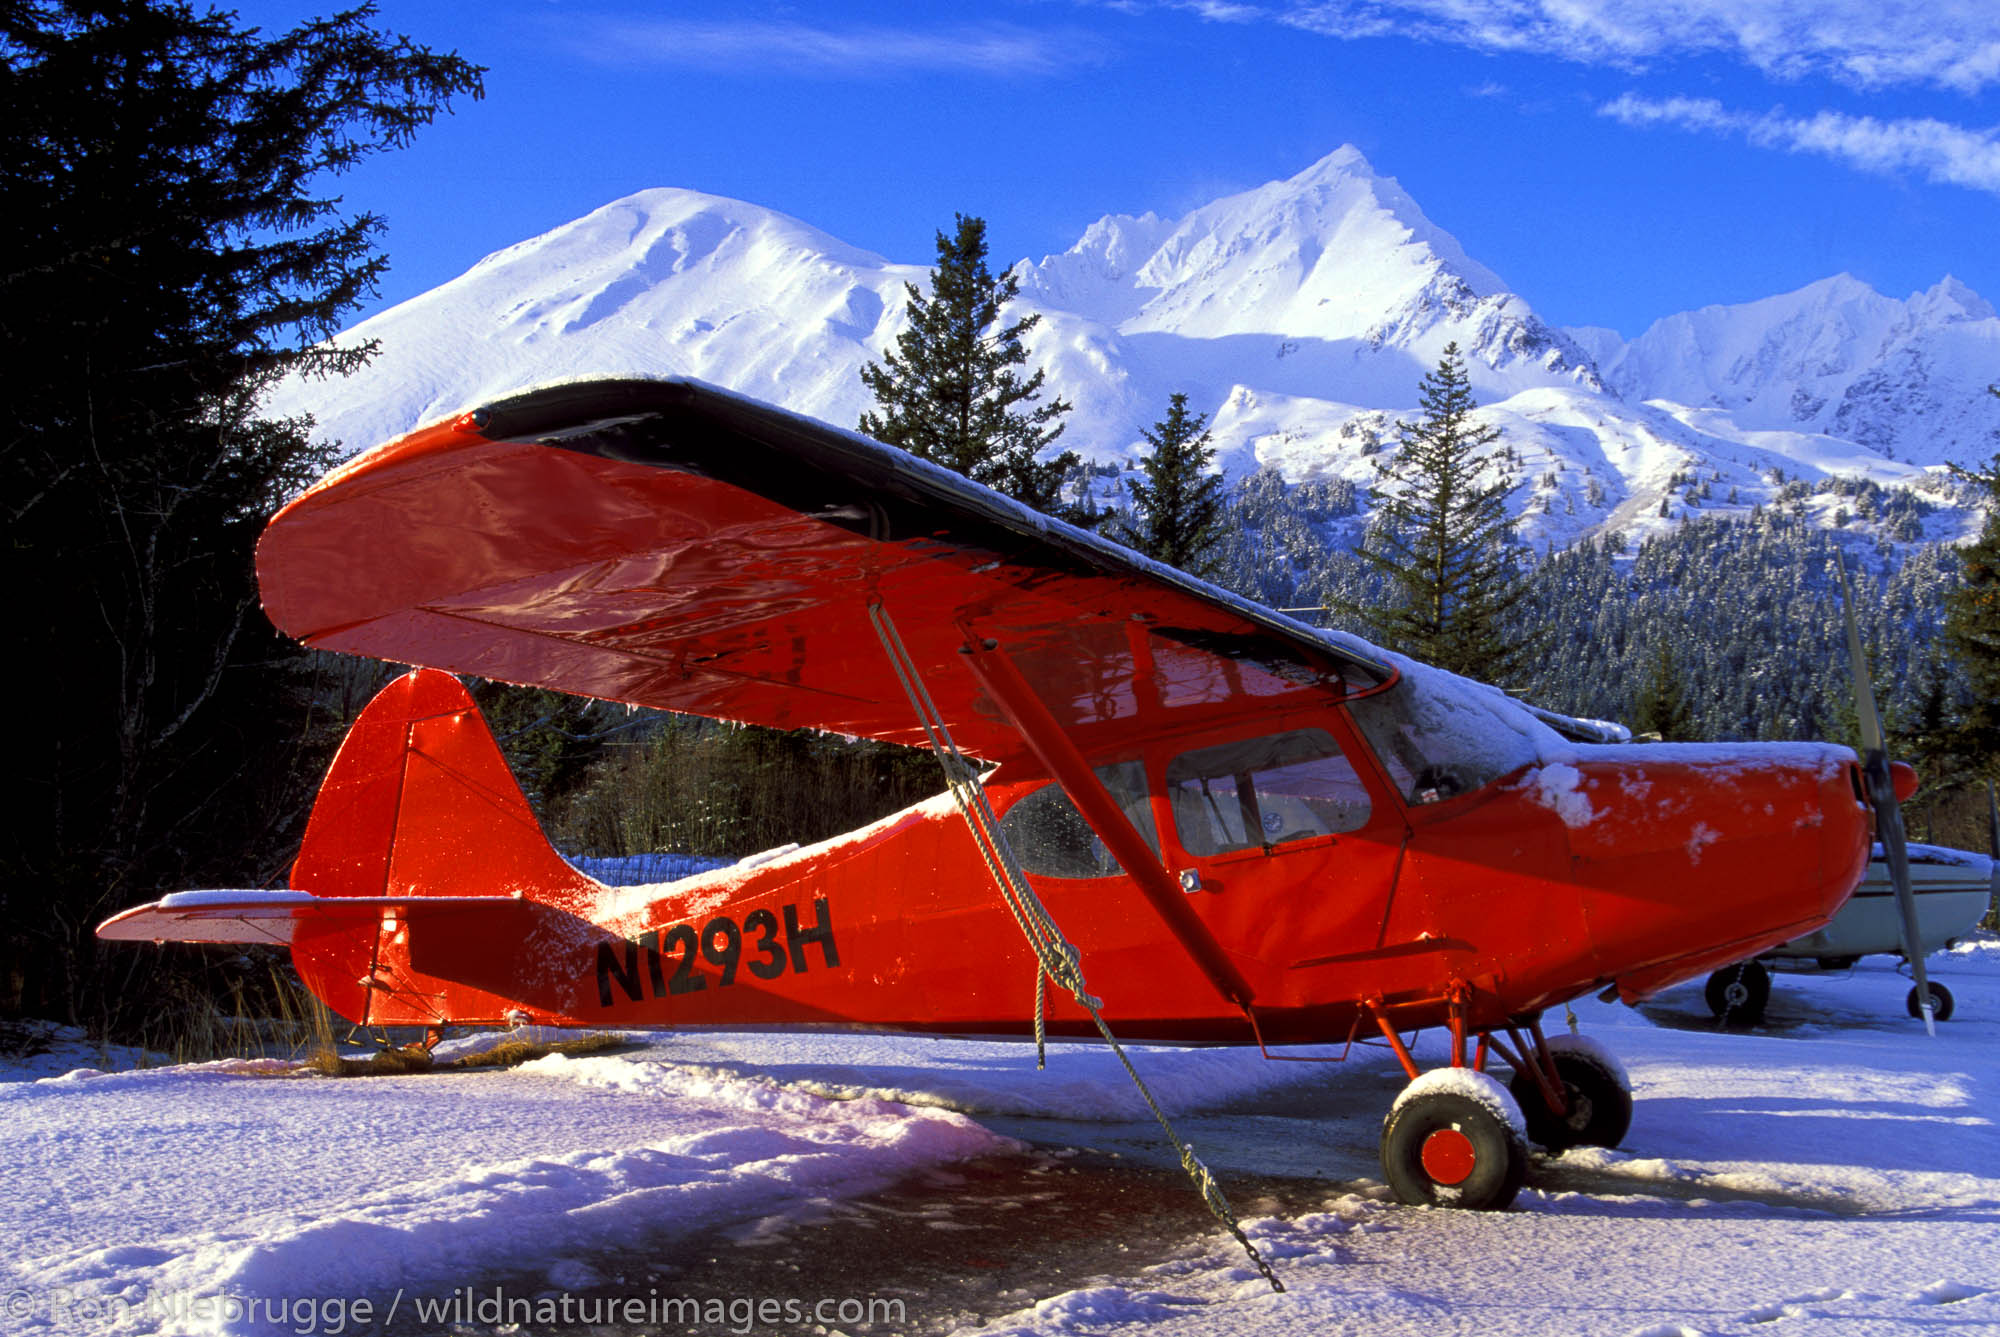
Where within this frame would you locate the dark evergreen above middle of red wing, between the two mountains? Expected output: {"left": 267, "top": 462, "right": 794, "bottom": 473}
{"left": 860, "top": 214, "right": 1084, "bottom": 518}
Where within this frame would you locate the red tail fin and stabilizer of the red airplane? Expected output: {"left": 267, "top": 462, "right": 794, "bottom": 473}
{"left": 98, "top": 669, "right": 604, "bottom": 1027}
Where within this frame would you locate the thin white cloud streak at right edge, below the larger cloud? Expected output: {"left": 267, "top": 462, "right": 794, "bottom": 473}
{"left": 1598, "top": 94, "right": 2000, "bottom": 194}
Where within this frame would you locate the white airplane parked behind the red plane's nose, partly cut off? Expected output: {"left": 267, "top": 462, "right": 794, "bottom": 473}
{"left": 1708, "top": 845, "right": 2000, "bottom": 1025}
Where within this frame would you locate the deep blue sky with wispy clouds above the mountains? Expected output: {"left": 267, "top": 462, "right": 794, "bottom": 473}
{"left": 234, "top": 0, "right": 2000, "bottom": 336}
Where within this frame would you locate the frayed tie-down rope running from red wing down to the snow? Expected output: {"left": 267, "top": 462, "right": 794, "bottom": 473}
{"left": 868, "top": 602, "right": 1284, "bottom": 1291}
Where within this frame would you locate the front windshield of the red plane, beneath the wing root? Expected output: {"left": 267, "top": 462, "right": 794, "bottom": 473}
{"left": 1348, "top": 677, "right": 1536, "bottom": 805}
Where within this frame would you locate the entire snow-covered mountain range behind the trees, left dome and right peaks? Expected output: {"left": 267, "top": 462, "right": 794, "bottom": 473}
{"left": 272, "top": 148, "right": 2000, "bottom": 548}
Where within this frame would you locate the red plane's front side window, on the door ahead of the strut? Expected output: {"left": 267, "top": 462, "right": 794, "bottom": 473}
{"left": 1166, "top": 729, "right": 1368, "bottom": 855}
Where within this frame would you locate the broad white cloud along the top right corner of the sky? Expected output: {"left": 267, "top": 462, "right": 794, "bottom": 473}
{"left": 1264, "top": 0, "right": 2000, "bottom": 92}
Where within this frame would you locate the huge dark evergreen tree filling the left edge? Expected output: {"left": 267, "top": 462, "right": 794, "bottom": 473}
{"left": 0, "top": 0, "right": 480, "bottom": 1023}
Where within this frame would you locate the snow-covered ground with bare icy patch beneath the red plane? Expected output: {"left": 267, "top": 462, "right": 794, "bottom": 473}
{"left": 0, "top": 937, "right": 2000, "bottom": 1337}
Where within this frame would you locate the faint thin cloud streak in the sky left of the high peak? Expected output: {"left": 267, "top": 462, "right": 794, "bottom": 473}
{"left": 564, "top": 18, "right": 1100, "bottom": 78}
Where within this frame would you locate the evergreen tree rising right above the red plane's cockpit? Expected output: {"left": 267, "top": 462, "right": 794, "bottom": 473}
{"left": 1342, "top": 344, "right": 1526, "bottom": 683}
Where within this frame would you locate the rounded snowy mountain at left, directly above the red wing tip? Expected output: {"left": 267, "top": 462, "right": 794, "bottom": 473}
{"left": 272, "top": 190, "right": 928, "bottom": 460}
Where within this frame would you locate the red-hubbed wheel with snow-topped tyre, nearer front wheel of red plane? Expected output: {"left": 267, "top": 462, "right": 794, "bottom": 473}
{"left": 1382, "top": 1069, "right": 1528, "bottom": 1211}
